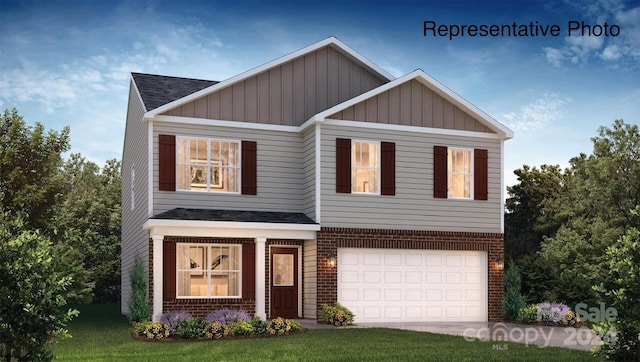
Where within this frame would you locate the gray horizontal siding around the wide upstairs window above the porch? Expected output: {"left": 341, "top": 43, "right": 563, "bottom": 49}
{"left": 153, "top": 122, "right": 304, "bottom": 215}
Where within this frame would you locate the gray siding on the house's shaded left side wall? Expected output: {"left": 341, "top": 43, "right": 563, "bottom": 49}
{"left": 121, "top": 81, "right": 149, "bottom": 314}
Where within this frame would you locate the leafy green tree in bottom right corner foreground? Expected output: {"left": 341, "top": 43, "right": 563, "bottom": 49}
{"left": 594, "top": 206, "right": 640, "bottom": 361}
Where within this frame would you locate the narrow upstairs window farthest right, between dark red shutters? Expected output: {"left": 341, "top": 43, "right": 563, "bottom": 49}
{"left": 447, "top": 148, "right": 473, "bottom": 199}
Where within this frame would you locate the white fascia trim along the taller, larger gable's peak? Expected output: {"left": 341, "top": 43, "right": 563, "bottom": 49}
{"left": 145, "top": 36, "right": 394, "bottom": 118}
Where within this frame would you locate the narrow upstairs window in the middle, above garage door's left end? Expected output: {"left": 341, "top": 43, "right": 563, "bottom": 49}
{"left": 351, "top": 141, "right": 380, "bottom": 194}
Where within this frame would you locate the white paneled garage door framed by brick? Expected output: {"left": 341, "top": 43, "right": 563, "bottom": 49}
{"left": 338, "top": 248, "right": 487, "bottom": 323}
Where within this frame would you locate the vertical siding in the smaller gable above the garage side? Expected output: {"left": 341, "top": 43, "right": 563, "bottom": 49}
{"left": 328, "top": 79, "right": 491, "bottom": 132}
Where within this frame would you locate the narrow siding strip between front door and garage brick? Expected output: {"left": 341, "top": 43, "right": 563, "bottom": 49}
{"left": 302, "top": 240, "right": 318, "bottom": 319}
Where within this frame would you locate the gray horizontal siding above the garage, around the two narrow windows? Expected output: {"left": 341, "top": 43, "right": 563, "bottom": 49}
{"left": 321, "top": 124, "right": 502, "bottom": 232}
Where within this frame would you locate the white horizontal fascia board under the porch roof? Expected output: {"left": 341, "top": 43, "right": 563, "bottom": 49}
{"left": 143, "top": 219, "right": 320, "bottom": 240}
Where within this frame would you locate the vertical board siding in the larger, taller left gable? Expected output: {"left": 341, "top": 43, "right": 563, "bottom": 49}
{"left": 165, "top": 46, "right": 387, "bottom": 126}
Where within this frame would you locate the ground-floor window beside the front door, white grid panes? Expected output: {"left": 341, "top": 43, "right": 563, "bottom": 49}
{"left": 176, "top": 244, "right": 242, "bottom": 298}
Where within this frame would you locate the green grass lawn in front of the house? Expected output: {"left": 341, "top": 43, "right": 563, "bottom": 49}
{"left": 54, "top": 304, "right": 595, "bottom": 362}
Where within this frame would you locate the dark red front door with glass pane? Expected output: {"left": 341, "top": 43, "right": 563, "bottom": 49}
{"left": 271, "top": 248, "right": 298, "bottom": 318}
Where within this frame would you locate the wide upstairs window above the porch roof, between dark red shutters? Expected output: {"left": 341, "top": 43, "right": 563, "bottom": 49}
{"left": 177, "top": 137, "right": 240, "bottom": 193}
